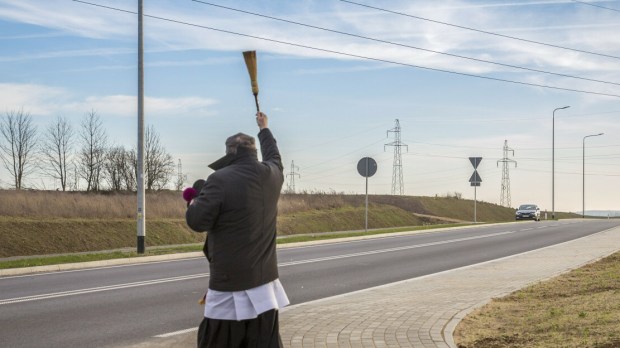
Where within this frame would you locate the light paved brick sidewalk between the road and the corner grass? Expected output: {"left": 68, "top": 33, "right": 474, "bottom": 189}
{"left": 127, "top": 224, "right": 620, "bottom": 348}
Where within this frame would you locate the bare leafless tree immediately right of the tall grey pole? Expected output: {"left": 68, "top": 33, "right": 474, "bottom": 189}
{"left": 144, "top": 126, "right": 174, "bottom": 190}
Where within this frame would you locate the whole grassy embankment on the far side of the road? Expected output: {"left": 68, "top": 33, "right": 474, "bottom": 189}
{"left": 0, "top": 190, "right": 560, "bottom": 257}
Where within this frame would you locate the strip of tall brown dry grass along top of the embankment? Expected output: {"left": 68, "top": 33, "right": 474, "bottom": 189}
{"left": 0, "top": 190, "right": 576, "bottom": 222}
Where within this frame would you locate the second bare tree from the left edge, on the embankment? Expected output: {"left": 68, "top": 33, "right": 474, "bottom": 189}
{"left": 41, "top": 116, "right": 73, "bottom": 191}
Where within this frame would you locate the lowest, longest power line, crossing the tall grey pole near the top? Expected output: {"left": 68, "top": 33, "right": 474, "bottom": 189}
{"left": 73, "top": 0, "right": 620, "bottom": 98}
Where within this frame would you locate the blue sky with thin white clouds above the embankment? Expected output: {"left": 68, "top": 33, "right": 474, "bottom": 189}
{"left": 0, "top": 0, "right": 620, "bottom": 212}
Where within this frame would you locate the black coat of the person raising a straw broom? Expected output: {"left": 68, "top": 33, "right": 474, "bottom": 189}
{"left": 185, "top": 128, "right": 284, "bottom": 291}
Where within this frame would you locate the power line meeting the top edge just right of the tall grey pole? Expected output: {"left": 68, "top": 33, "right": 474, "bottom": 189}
{"left": 192, "top": 0, "right": 620, "bottom": 86}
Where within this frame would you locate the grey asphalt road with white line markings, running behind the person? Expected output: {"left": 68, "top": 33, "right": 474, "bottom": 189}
{"left": 0, "top": 220, "right": 620, "bottom": 348}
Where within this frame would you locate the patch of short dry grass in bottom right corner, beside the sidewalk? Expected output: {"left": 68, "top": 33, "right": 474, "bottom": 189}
{"left": 454, "top": 253, "right": 620, "bottom": 348}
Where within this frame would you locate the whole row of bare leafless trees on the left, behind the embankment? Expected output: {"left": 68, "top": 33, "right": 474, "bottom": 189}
{"left": 0, "top": 110, "right": 183, "bottom": 192}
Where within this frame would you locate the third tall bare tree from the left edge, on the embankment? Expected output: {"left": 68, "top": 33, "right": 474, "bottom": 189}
{"left": 78, "top": 110, "right": 108, "bottom": 191}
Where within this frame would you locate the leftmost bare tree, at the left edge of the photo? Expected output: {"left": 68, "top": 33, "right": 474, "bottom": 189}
{"left": 0, "top": 110, "right": 37, "bottom": 190}
